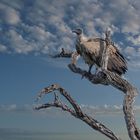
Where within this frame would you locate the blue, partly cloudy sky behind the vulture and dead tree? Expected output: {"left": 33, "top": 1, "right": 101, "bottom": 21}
{"left": 0, "top": 0, "right": 140, "bottom": 139}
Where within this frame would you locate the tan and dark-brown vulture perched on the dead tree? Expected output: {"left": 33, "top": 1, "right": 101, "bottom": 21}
{"left": 72, "top": 28, "right": 127, "bottom": 75}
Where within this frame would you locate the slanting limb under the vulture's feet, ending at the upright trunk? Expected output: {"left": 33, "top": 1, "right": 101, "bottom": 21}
{"left": 68, "top": 64, "right": 128, "bottom": 93}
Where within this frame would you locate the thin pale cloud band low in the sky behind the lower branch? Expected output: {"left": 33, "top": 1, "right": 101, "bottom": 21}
{"left": 0, "top": 104, "right": 140, "bottom": 117}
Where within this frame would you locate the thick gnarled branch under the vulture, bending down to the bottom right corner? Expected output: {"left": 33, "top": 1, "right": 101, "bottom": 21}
{"left": 68, "top": 64, "right": 140, "bottom": 140}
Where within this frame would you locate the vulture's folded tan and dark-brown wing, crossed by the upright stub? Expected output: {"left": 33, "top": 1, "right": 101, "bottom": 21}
{"left": 81, "top": 38, "right": 127, "bottom": 75}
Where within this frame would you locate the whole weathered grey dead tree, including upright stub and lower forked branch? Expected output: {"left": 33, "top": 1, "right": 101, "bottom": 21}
{"left": 35, "top": 32, "right": 140, "bottom": 140}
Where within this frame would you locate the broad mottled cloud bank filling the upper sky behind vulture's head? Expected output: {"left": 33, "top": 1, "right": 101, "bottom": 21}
{"left": 0, "top": 0, "right": 140, "bottom": 69}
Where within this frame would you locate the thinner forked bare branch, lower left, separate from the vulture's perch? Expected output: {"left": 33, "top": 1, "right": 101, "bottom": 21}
{"left": 35, "top": 84, "right": 120, "bottom": 140}
